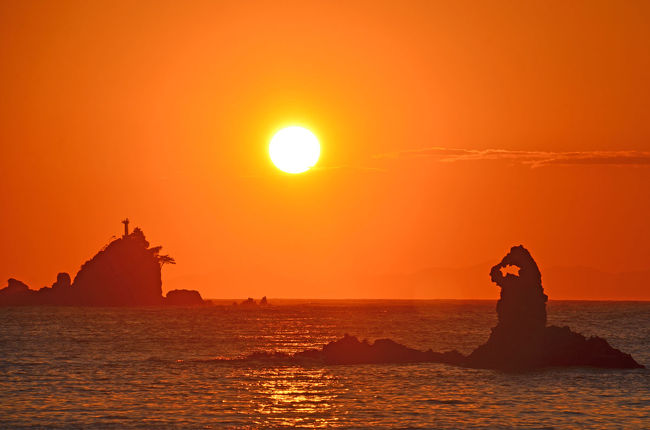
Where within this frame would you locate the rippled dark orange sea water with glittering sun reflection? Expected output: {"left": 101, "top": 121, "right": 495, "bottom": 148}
{"left": 0, "top": 301, "right": 650, "bottom": 428}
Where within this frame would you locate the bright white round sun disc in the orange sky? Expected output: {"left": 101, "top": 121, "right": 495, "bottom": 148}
{"left": 269, "top": 126, "right": 320, "bottom": 173}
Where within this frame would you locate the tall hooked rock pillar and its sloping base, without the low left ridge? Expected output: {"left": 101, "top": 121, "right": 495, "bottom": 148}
{"left": 464, "top": 245, "right": 643, "bottom": 370}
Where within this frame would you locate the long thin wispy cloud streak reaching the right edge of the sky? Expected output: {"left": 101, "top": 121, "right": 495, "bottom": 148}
{"left": 373, "top": 146, "right": 650, "bottom": 167}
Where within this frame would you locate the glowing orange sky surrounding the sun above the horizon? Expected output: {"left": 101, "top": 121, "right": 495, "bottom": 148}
{"left": 0, "top": 0, "right": 650, "bottom": 299}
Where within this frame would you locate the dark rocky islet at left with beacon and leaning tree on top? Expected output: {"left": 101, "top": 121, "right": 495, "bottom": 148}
{"left": 0, "top": 218, "right": 205, "bottom": 306}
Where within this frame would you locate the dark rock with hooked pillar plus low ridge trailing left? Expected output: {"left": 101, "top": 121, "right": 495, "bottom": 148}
{"left": 246, "top": 245, "right": 645, "bottom": 371}
